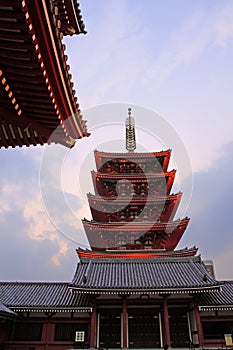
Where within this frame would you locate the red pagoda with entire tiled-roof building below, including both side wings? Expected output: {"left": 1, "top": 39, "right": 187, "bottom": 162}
{"left": 0, "top": 113, "right": 233, "bottom": 350}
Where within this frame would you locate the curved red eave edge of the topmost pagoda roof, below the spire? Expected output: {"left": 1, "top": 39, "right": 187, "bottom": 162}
{"left": 94, "top": 149, "right": 171, "bottom": 171}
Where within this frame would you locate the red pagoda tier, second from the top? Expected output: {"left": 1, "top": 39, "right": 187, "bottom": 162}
{"left": 91, "top": 170, "right": 176, "bottom": 196}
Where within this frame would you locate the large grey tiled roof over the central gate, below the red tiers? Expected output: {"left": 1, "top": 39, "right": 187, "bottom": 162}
{"left": 71, "top": 256, "right": 221, "bottom": 295}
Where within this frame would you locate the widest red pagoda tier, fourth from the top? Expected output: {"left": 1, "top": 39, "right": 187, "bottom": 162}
{"left": 83, "top": 218, "right": 189, "bottom": 251}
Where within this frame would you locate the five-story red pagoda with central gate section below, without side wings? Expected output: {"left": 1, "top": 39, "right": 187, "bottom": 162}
{"left": 71, "top": 109, "right": 220, "bottom": 349}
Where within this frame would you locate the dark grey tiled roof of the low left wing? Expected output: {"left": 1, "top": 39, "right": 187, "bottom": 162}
{"left": 0, "top": 282, "right": 91, "bottom": 311}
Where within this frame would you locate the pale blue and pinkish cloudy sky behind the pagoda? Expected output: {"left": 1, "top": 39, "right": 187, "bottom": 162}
{"left": 0, "top": 0, "right": 233, "bottom": 281}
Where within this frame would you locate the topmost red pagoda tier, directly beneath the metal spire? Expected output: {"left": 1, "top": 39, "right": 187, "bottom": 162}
{"left": 94, "top": 149, "right": 171, "bottom": 173}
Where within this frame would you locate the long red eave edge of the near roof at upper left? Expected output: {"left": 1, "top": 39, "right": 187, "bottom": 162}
{"left": 23, "top": 0, "right": 83, "bottom": 139}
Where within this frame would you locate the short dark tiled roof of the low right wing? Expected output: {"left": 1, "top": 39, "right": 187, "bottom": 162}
{"left": 197, "top": 281, "right": 233, "bottom": 310}
